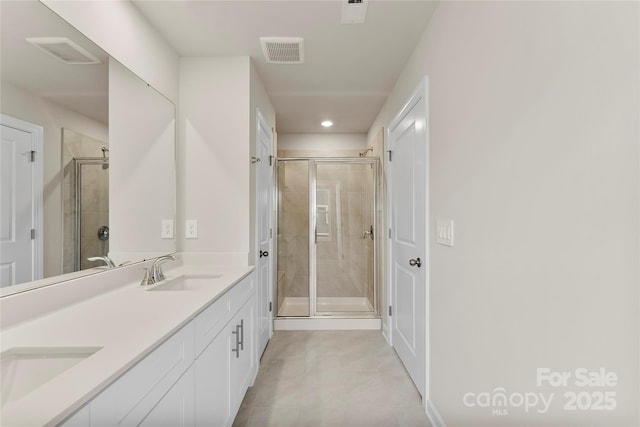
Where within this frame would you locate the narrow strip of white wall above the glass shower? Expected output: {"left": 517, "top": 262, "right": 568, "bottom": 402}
{"left": 278, "top": 133, "right": 367, "bottom": 151}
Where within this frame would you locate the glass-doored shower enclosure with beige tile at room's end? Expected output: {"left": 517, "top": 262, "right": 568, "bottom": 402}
{"left": 276, "top": 158, "right": 378, "bottom": 318}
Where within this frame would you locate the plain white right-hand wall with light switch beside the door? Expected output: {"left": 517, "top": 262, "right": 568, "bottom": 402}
{"left": 369, "top": 2, "right": 640, "bottom": 427}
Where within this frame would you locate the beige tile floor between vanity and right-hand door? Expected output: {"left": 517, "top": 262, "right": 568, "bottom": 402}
{"left": 233, "top": 331, "right": 431, "bottom": 427}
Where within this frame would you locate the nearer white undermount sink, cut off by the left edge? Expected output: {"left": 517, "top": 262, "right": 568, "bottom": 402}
{"left": 0, "top": 347, "right": 102, "bottom": 406}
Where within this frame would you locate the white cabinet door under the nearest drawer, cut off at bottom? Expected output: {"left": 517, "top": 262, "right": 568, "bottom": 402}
{"left": 138, "top": 365, "right": 195, "bottom": 427}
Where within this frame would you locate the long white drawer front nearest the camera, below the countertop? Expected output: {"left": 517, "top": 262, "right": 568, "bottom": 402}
{"left": 90, "top": 322, "right": 194, "bottom": 427}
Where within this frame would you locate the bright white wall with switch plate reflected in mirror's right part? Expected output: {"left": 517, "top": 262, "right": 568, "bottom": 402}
{"left": 109, "top": 59, "right": 177, "bottom": 263}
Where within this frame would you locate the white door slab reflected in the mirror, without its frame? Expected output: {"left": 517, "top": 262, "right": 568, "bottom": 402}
{"left": 0, "top": 125, "right": 35, "bottom": 287}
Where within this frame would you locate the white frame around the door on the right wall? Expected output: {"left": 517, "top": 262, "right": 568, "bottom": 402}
{"left": 384, "top": 76, "right": 431, "bottom": 409}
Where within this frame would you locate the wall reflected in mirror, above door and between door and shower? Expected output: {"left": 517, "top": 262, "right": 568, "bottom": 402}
{"left": 0, "top": 81, "right": 109, "bottom": 277}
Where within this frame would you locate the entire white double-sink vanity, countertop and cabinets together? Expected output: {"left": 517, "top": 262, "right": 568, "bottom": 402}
{"left": 0, "top": 266, "right": 259, "bottom": 426}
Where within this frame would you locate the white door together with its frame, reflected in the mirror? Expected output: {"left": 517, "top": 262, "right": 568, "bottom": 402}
{"left": 0, "top": 115, "right": 42, "bottom": 287}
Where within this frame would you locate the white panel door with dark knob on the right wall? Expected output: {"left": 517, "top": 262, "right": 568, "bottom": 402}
{"left": 388, "top": 78, "right": 428, "bottom": 400}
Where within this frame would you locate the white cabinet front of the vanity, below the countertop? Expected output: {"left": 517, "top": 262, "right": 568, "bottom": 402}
{"left": 60, "top": 273, "right": 258, "bottom": 427}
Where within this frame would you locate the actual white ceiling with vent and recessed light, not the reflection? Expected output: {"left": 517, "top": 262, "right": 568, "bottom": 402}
{"left": 134, "top": 0, "right": 436, "bottom": 133}
